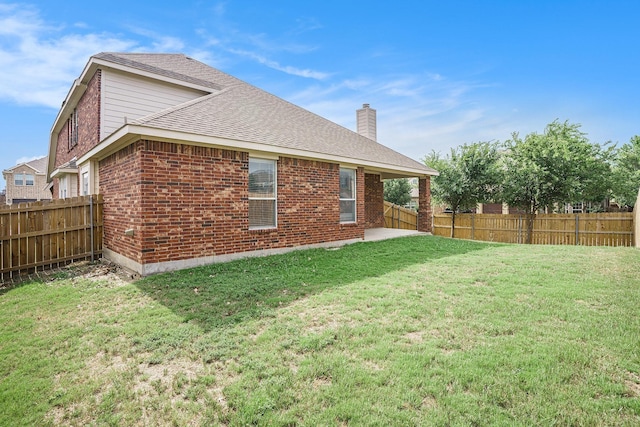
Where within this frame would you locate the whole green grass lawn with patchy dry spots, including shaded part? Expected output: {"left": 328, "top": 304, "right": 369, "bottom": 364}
{"left": 0, "top": 236, "right": 640, "bottom": 426}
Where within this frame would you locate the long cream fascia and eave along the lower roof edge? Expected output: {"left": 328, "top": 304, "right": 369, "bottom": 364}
{"left": 77, "top": 124, "right": 437, "bottom": 177}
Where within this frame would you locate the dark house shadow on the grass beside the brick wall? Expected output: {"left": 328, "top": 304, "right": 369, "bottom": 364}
{"left": 136, "top": 236, "right": 487, "bottom": 332}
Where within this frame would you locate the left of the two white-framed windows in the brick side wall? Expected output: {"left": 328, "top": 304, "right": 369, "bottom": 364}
{"left": 249, "top": 158, "right": 276, "bottom": 228}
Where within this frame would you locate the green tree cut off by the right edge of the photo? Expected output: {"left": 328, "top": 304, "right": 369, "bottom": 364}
{"left": 613, "top": 135, "right": 640, "bottom": 208}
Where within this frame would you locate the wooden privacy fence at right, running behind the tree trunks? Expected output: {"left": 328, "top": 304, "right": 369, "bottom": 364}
{"left": 433, "top": 212, "right": 634, "bottom": 246}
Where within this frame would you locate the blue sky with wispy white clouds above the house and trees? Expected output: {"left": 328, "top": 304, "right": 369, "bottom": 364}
{"left": 0, "top": 0, "right": 640, "bottom": 188}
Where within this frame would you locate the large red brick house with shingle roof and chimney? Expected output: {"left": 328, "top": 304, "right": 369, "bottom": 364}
{"left": 48, "top": 53, "right": 437, "bottom": 275}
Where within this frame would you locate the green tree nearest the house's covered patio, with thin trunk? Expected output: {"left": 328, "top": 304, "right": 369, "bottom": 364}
{"left": 423, "top": 142, "right": 501, "bottom": 237}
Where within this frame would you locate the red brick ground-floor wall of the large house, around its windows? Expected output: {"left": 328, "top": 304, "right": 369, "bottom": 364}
{"left": 99, "top": 141, "right": 365, "bottom": 264}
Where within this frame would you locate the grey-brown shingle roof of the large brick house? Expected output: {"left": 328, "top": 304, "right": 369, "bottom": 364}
{"left": 95, "top": 53, "right": 434, "bottom": 173}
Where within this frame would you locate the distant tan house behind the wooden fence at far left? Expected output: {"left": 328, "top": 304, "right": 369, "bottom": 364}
{"left": 2, "top": 157, "right": 51, "bottom": 205}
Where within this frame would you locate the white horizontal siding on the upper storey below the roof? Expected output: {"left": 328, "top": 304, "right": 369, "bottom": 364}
{"left": 100, "top": 70, "right": 206, "bottom": 140}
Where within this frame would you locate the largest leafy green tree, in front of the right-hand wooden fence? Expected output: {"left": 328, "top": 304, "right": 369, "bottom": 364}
{"left": 502, "top": 120, "right": 613, "bottom": 243}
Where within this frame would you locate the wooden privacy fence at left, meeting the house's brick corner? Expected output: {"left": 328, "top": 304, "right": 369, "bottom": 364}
{"left": 0, "top": 195, "right": 103, "bottom": 281}
